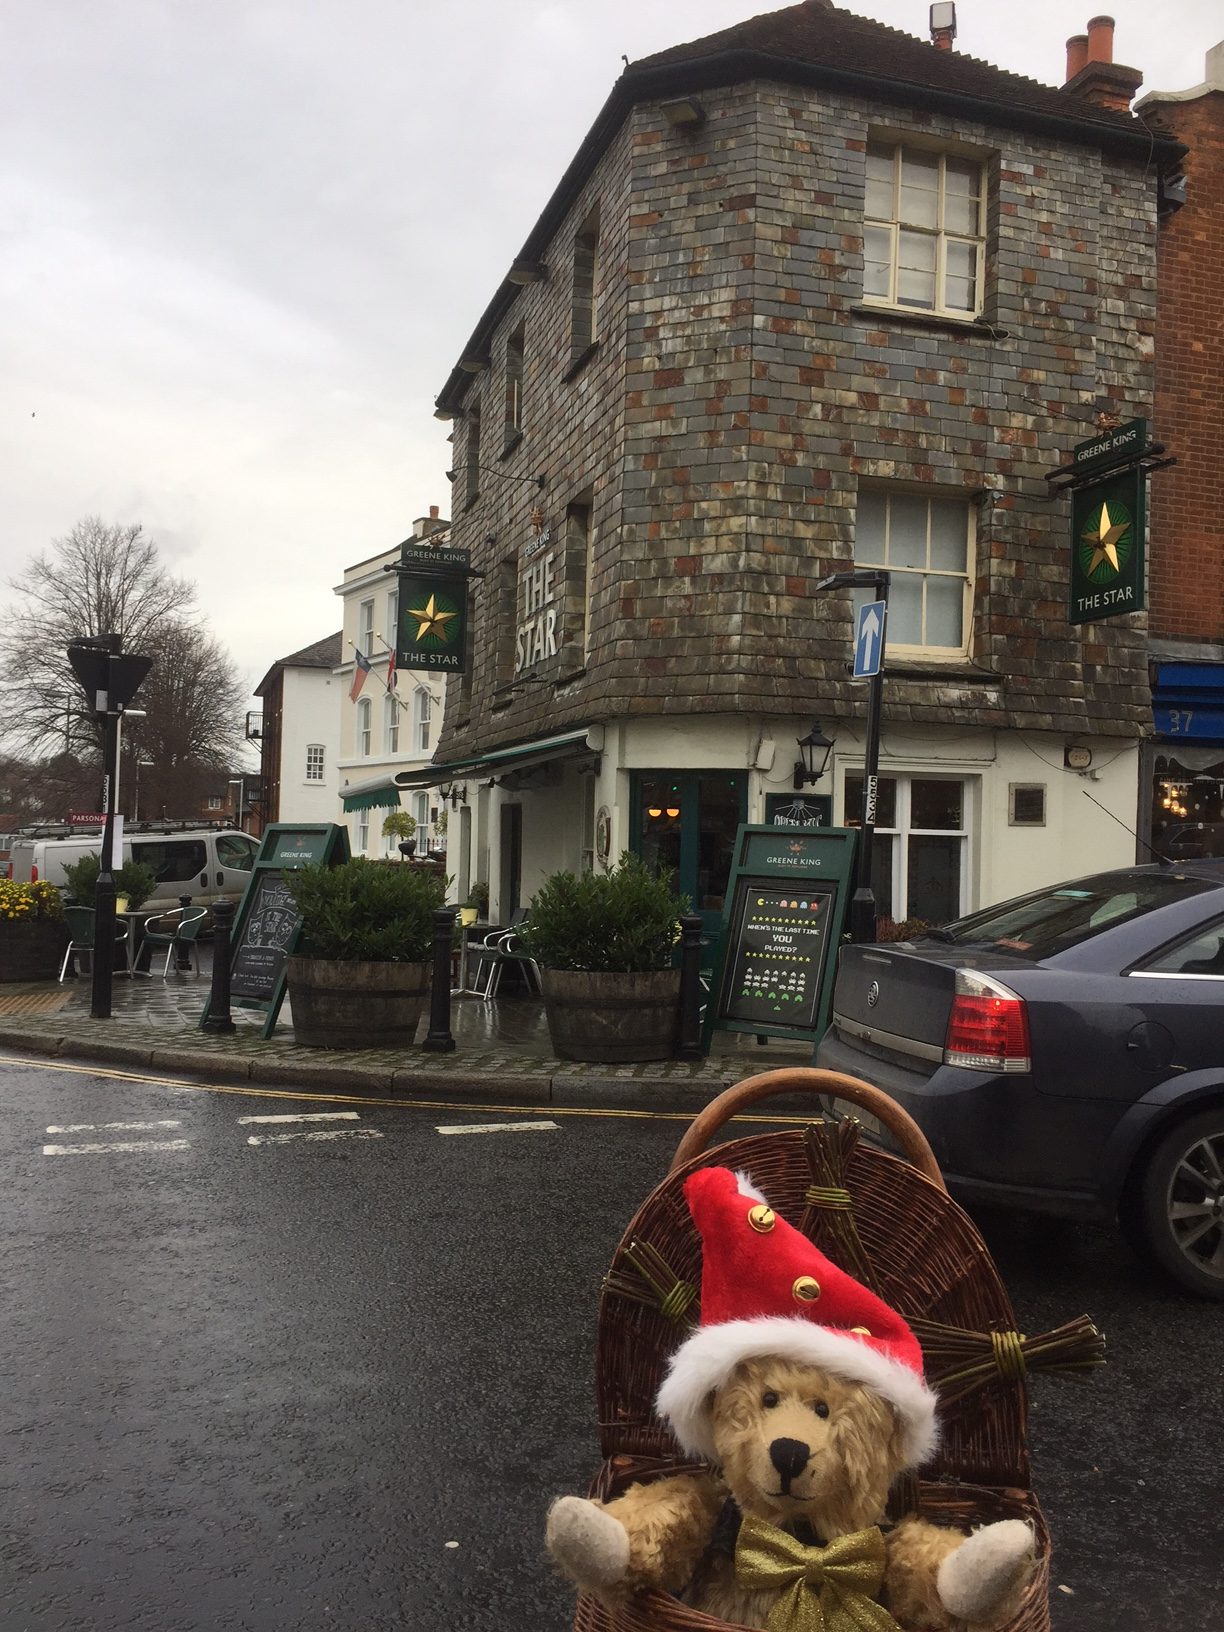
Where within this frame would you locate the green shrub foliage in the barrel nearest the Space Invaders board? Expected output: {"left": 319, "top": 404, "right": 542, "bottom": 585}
{"left": 517, "top": 852, "right": 689, "bottom": 974}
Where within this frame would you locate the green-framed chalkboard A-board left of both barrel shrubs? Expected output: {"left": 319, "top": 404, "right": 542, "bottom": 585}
{"left": 201, "top": 823, "right": 349, "bottom": 1036}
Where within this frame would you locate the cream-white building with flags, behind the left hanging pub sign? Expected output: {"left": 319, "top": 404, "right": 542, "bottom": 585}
{"left": 328, "top": 504, "right": 450, "bottom": 857}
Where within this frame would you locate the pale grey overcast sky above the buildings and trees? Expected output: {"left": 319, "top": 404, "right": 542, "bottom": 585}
{"left": 0, "top": 0, "right": 1224, "bottom": 711}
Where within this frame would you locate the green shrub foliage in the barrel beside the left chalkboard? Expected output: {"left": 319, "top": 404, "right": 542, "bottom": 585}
{"left": 284, "top": 855, "right": 446, "bottom": 963}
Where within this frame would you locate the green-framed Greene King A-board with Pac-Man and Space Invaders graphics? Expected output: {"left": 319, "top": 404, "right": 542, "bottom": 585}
{"left": 705, "top": 826, "right": 857, "bottom": 1044}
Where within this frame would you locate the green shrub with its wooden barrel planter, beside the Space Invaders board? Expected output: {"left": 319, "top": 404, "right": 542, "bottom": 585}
{"left": 519, "top": 852, "right": 689, "bottom": 1061}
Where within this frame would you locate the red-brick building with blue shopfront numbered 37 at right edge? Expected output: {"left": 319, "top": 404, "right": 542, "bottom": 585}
{"left": 1138, "top": 42, "right": 1224, "bottom": 857}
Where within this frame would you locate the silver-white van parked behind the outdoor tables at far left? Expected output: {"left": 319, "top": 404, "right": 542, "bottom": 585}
{"left": 10, "top": 824, "right": 259, "bottom": 912}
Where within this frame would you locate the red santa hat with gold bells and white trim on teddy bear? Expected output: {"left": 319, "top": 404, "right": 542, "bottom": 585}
{"left": 656, "top": 1167, "right": 937, "bottom": 1467}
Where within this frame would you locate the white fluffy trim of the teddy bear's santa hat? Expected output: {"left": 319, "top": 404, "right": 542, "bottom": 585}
{"left": 656, "top": 1315, "right": 938, "bottom": 1467}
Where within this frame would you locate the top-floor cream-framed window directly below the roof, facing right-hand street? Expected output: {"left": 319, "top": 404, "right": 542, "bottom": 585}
{"left": 863, "top": 142, "right": 986, "bottom": 317}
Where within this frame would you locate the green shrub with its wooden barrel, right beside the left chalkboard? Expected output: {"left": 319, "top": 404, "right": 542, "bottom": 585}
{"left": 284, "top": 855, "right": 446, "bottom": 1048}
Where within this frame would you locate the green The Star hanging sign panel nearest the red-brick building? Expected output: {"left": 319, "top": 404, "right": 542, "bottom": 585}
{"left": 1067, "top": 473, "right": 1146, "bottom": 623}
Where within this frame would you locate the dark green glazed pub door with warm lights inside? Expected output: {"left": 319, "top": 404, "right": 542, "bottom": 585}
{"left": 630, "top": 770, "right": 747, "bottom": 937}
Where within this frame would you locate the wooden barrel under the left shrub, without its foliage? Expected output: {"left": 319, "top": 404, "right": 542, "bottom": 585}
{"left": 286, "top": 958, "right": 429, "bottom": 1048}
